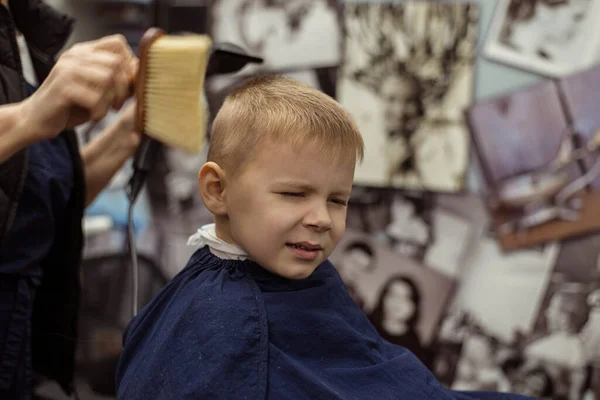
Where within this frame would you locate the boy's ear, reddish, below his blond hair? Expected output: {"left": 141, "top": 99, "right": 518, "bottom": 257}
{"left": 198, "top": 161, "right": 227, "bottom": 215}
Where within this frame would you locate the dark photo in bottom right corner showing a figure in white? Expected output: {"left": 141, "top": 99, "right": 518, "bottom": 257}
{"left": 511, "top": 234, "right": 600, "bottom": 400}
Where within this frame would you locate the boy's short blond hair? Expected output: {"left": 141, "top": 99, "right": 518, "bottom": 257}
{"left": 208, "top": 75, "right": 364, "bottom": 175}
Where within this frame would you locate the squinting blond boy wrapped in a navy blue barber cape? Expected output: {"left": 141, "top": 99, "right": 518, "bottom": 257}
{"left": 116, "top": 76, "right": 532, "bottom": 400}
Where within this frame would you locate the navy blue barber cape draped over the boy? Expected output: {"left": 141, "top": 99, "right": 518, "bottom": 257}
{"left": 116, "top": 247, "right": 525, "bottom": 400}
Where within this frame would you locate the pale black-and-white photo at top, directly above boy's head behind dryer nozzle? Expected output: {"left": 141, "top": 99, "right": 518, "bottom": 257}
{"left": 210, "top": 0, "right": 342, "bottom": 74}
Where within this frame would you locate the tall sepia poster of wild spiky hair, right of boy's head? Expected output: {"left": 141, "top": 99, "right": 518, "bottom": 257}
{"left": 337, "top": 1, "right": 479, "bottom": 193}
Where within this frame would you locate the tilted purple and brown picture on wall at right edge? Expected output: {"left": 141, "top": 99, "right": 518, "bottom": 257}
{"left": 467, "top": 67, "right": 600, "bottom": 251}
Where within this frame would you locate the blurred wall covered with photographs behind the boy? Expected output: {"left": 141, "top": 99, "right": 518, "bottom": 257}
{"left": 69, "top": 0, "right": 600, "bottom": 400}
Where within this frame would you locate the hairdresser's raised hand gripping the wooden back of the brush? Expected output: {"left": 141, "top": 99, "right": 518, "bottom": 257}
{"left": 21, "top": 35, "right": 137, "bottom": 141}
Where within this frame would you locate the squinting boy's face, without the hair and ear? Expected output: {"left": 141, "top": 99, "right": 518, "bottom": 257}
{"left": 223, "top": 142, "right": 355, "bottom": 279}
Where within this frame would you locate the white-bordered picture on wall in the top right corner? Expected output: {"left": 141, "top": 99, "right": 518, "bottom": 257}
{"left": 484, "top": 0, "right": 600, "bottom": 78}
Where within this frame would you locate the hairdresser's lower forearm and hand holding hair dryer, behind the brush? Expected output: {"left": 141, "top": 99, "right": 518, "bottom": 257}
{"left": 81, "top": 103, "right": 140, "bottom": 206}
